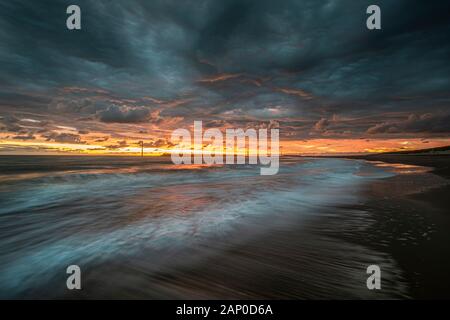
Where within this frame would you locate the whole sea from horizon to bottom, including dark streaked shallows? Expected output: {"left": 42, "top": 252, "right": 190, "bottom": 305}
{"left": 0, "top": 156, "right": 412, "bottom": 298}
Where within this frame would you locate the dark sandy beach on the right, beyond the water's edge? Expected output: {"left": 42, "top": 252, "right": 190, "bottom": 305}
{"left": 342, "top": 154, "right": 450, "bottom": 299}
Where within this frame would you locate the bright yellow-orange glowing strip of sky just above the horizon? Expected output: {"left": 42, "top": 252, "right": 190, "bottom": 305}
{"left": 0, "top": 138, "right": 450, "bottom": 156}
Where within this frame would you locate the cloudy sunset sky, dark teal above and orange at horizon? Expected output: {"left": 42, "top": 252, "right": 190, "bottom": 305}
{"left": 0, "top": 0, "right": 450, "bottom": 154}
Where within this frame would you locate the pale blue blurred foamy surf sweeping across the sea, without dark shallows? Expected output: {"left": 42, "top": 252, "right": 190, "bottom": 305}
{"left": 0, "top": 159, "right": 400, "bottom": 296}
